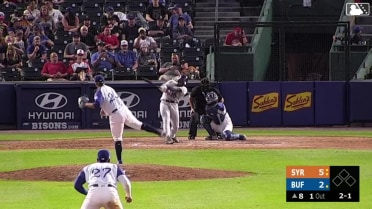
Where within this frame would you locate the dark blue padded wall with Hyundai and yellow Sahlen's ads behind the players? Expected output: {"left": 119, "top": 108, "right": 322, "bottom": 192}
{"left": 0, "top": 81, "right": 372, "bottom": 130}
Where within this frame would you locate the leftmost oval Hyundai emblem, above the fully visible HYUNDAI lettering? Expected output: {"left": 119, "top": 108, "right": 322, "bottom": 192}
{"left": 35, "top": 92, "right": 67, "bottom": 110}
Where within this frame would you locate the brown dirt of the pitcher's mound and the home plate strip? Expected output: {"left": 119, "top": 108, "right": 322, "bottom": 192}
{"left": 0, "top": 136, "right": 372, "bottom": 181}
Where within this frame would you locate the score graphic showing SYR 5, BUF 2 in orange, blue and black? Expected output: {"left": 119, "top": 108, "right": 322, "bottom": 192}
{"left": 286, "top": 166, "right": 359, "bottom": 202}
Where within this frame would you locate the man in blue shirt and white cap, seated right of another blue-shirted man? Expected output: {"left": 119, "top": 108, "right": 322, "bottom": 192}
{"left": 115, "top": 40, "right": 138, "bottom": 71}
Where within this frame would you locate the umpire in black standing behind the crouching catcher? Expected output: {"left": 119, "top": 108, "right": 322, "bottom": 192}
{"left": 189, "top": 78, "right": 223, "bottom": 140}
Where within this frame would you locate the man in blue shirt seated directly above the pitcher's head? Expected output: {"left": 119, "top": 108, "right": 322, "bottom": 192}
{"left": 91, "top": 41, "right": 115, "bottom": 69}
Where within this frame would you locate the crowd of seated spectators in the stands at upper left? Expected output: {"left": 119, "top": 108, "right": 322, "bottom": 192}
{"left": 0, "top": 0, "right": 203, "bottom": 81}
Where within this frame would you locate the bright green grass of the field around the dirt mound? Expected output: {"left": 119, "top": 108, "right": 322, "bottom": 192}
{"left": 0, "top": 129, "right": 372, "bottom": 209}
